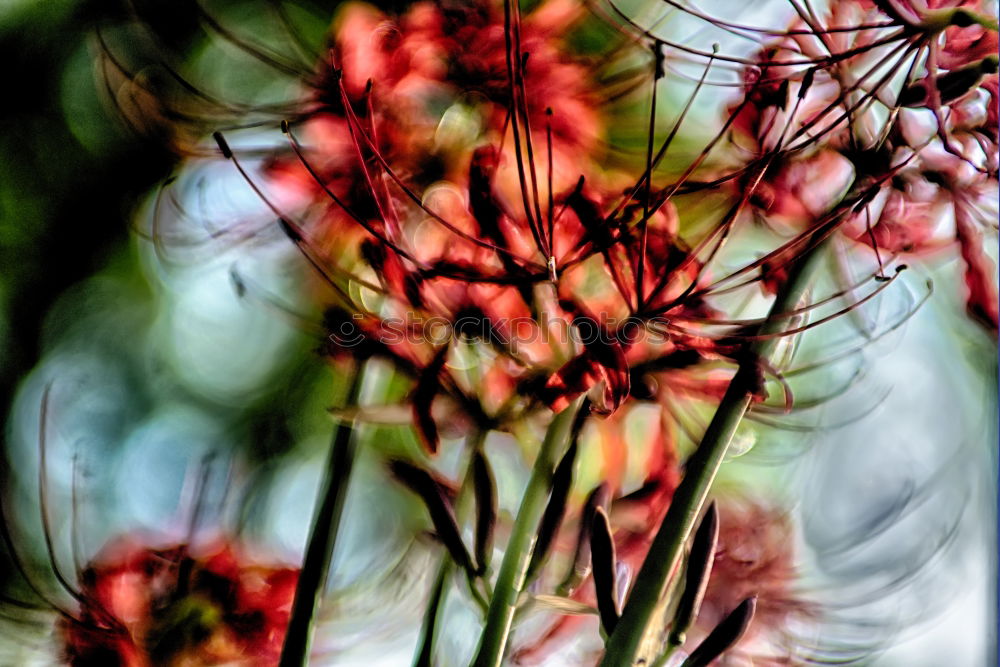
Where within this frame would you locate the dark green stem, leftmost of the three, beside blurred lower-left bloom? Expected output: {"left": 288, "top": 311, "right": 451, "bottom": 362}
{"left": 278, "top": 370, "right": 362, "bottom": 667}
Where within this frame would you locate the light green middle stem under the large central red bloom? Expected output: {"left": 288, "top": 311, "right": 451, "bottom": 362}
{"left": 472, "top": 397, "right": 583, "bottom": 667}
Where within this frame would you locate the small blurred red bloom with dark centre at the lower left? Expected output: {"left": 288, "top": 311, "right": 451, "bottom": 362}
{"left": 57, "top": 536, "right": 297, "bottom": 667}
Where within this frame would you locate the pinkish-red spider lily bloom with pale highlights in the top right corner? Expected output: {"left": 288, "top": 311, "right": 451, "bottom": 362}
{"left": 704, "top": 1, "right": 997, "bottom": 334}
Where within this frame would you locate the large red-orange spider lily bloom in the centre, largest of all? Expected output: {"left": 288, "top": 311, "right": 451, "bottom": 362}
{"left": 244, "top": 2, "right": 752, "bottom": 451}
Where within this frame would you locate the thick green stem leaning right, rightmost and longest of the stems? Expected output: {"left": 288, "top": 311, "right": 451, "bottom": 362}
{"left": 600, "top": 241, "right": 826, "bottom": 667}
